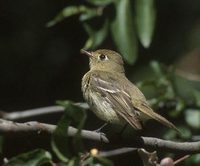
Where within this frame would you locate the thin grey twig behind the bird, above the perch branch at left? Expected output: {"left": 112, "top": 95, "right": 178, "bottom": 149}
{"left": 0, "top": 103, "right": 89, "bottom": 120}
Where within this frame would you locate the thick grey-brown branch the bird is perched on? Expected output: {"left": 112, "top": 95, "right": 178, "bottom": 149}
{"left": 0, "top": 119, "right": 200, "bottom": 154}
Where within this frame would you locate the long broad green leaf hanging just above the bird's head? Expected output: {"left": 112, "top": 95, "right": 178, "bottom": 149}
{"left": 111, "top": 0, "right": 137, "bottom": 64}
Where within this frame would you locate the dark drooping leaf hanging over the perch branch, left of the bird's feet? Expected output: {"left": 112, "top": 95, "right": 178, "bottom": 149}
{"left": 51, "top": 101, "right": 86, "bottom": 162}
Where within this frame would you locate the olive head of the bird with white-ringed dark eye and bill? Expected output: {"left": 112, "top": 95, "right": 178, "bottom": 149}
{"left": 81, "top": 49, "right": 124, "bottom": 73}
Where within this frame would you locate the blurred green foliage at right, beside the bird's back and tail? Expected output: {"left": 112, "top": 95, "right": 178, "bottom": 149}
{"left": 138, "top": 61, "right": 200, "bottom": 143}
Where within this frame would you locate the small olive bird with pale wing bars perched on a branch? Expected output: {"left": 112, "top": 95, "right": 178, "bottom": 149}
{"left": 81, "top": 49, "right": 178, "bottom": 131}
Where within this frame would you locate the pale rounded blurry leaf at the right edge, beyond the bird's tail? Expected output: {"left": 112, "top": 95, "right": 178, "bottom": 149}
{"left": 185, "top": 109, "right": 200, "bottom": 129}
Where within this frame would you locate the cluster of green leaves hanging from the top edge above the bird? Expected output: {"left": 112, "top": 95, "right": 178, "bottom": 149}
{"left": 47, "top": 0, "right": 156, "bottom": 64}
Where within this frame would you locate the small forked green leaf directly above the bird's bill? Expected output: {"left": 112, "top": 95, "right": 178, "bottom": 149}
{"left": 84, "top": 20, "right": 109, "bottom": 50}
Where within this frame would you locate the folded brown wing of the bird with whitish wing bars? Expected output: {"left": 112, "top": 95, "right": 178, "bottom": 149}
{"left": 90, "top": 73, "right": 142, "bottom": 130}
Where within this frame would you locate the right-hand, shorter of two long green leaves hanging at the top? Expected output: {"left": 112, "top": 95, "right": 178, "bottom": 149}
{"left": 135, "top": 0, "right": 156, "bottom": 48}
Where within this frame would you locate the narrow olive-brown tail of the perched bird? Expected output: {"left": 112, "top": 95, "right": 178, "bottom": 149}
{"left": 136, "top": 103, "right": 180, "bottom": 133}
